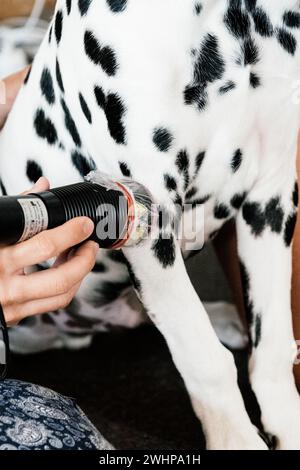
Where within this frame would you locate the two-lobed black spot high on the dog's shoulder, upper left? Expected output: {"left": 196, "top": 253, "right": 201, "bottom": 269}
{"left": 84, "top": 31, "right": 118, "bottom": 76}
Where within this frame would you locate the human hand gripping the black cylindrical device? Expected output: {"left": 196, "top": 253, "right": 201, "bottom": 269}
{"left": 0, "top": 178, "right": 98, "bottom": 326}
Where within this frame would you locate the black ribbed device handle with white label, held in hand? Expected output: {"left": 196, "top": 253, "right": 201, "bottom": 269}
{"left": 0, "top": 182, "right": 128, "bottom": 248}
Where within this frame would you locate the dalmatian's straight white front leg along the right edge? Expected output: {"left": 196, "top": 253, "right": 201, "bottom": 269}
{"left": 237, "top": 174, "right": 300, "bottom": 449}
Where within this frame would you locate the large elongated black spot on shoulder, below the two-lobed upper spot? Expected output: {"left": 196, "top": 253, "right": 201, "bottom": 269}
{"left": 104, "top": 93, "right": 126, "bottom": 145}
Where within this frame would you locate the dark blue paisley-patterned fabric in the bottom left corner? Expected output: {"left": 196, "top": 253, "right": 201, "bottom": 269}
{"left": 0, "top": 380, "right": 112, "bottom": 450}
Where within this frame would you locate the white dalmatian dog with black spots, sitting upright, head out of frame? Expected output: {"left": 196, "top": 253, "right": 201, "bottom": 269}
{"left": 0, "top": 0, "right": 300, "bottom": 449}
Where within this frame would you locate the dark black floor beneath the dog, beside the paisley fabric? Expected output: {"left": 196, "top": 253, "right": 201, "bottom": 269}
{"left": 10, "top": 325, "right": 258, "bottom": 450}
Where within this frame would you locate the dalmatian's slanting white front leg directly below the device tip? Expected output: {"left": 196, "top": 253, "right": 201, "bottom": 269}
{"left": 124, "top": 228, "right": 266, "bottom": 449}
